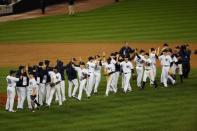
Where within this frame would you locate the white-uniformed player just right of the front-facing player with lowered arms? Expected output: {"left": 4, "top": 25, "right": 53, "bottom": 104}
{"left": 134, "top": 50, "right": 145, "bottom": 88}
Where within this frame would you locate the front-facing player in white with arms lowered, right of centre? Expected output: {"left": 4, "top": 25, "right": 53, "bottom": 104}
{"left": 120, "top": 56, "right": 134, "bottom": 93}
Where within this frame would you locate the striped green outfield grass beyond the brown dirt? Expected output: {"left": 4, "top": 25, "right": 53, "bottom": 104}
{"left": 0, "top": 0, "right": 197, "bottom": 43}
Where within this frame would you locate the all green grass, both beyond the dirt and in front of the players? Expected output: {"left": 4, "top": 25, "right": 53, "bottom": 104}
{"left": 0, "top": 0, "right": 197, "bottom": 131}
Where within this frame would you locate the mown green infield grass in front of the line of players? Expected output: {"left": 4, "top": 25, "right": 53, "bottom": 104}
{"left": 0, "top": 69, "right": 197, "bottom": 131}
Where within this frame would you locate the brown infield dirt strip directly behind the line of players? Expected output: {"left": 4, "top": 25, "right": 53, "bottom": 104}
{"left": 0, "top": 42, "right": 197, "bottom": 68}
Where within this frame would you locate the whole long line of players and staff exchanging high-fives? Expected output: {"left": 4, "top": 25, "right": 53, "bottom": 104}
{"left": 5, "top": 43, "right": 191, "bottom": 112}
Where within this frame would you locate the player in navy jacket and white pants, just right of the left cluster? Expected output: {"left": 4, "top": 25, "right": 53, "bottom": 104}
{"left": 65, "top": 58, "right": 79, "bottom": 97}
